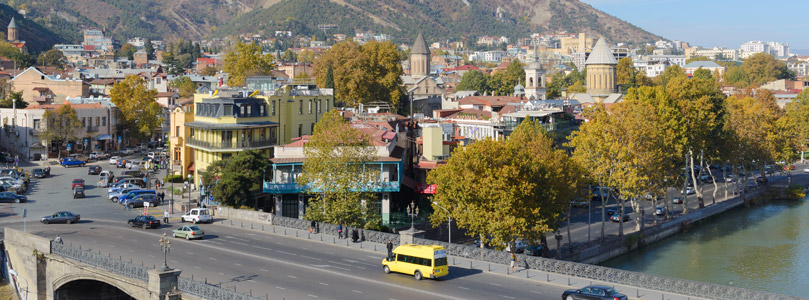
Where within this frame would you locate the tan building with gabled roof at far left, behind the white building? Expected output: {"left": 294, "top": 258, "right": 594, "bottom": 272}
{"left": 11, "top": 67, "right": 90, "bottom": 104}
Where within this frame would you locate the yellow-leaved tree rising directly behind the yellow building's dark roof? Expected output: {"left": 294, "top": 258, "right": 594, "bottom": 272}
{"left": 224, "top": 42, "right": 275, "bottom": 86}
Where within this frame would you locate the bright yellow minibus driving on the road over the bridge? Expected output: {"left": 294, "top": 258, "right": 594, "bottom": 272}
{"left": 382, "top": 244, "right": 449, "bottom": 280}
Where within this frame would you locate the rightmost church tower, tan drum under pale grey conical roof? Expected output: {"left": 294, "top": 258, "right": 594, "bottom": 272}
{"left": 584, "top": 38, "right": 618, "bottom": 98}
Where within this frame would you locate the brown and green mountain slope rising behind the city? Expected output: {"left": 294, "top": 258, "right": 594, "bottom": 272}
{"left": 0, "top": 0, "right": 661, "bottom": 49}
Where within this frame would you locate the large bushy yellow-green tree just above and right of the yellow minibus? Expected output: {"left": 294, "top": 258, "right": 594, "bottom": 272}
{"left": 427, "top": 120, "right": 582, "bottom": 249}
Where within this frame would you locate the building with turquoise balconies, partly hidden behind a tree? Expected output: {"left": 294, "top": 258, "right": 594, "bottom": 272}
{"left": 263, "top": 124, "right": 404, "bottom": 224}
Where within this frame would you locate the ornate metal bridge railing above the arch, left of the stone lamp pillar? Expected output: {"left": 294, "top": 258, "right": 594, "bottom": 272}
{"left": 51, "top": 241, "right": 149, "bottom": 281}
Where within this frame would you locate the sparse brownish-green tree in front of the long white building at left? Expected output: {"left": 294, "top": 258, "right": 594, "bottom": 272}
{"left": 40, "top": 104, "right": 81, "bottom": 158}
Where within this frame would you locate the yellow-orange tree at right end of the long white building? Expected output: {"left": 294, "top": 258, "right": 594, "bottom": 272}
{"left": 110, "top": 75, "right": 163, "bottom": 137}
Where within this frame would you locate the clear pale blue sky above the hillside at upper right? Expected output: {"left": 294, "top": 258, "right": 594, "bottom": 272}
{"left": 580, "top": 0, "right": 809, "bottom": 53}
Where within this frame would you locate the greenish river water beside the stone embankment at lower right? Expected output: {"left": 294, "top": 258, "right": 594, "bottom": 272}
{"left": 602, "top": 197, "right": 809, "bottom": 297}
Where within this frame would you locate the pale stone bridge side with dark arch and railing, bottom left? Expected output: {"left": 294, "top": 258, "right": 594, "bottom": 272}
{"left": 3, "top": 228, "right": 259, "bottom": 300}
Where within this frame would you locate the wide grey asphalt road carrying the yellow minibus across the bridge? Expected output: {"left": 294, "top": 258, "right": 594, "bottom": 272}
{"left": 0, "top": 157, "right": 566, "bottom": 299}
